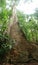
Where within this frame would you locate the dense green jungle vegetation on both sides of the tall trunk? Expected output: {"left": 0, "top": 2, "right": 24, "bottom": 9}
{"left": 0, "top": 0, "right": 38, "bottom": 64}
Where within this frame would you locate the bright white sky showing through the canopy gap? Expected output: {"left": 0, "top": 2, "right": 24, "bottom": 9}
{"left": 17, "top": 0, "right": 38, "bottom": 14}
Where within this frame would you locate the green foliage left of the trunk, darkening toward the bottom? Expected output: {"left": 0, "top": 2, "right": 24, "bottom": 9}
{"left": 0, "top": 0, "right": 13, "bottom": 61}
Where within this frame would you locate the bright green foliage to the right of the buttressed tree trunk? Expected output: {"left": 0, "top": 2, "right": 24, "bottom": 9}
{"left": 18, "top": 13, "right": 38, "bottom": 43}
